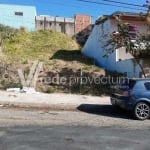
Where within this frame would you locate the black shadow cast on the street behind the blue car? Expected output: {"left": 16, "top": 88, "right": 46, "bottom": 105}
{"left": 77, "top": 104, "right": 132, "bottom": 119}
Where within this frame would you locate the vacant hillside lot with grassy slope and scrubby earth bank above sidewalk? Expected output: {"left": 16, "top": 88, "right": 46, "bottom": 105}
{"left": 0, "top": 30, "right": 109, "bottom": 95}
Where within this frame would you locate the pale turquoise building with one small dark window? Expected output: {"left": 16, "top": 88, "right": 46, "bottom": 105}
{"left": 0, "top": 4, "right": 36, "bottom": 31}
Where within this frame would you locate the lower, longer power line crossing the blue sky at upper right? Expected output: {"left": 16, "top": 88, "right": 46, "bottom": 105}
{"left": 78, "top": 0, "right": 147, "bottom": 11}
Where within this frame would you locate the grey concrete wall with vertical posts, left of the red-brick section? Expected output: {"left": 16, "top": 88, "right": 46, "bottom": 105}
{"left": 36, "top": 16, "right": 75, "bottom": 35}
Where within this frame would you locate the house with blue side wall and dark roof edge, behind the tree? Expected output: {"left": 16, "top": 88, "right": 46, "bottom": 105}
{"left": 82, "top": 12, "right": 148, "bottom": 77}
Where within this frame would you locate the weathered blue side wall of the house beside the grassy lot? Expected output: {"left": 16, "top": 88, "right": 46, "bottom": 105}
{"left": 82, "top": 20, "right": 141, "bottom": 77}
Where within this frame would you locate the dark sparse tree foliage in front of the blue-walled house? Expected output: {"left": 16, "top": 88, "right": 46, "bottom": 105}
{"left": 105, "top": 13, "right": 150, "bottom": 57}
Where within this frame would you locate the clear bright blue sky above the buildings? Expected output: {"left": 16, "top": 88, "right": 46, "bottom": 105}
{"left": 0, "top": 0, "right": 146, "bottom": 21}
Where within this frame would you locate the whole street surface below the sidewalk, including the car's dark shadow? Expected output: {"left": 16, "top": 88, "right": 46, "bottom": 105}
{"left": 0, "top": 105, "right": 150, "bottom": 150}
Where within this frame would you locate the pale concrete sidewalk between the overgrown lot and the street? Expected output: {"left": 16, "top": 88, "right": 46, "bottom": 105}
{"left": 0, "top": 91, "right": 110, "bottom": 110}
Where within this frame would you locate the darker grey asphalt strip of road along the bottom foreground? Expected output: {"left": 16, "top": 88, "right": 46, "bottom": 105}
{"left": 0, "top": 126, "right": 150, "bottom": 150}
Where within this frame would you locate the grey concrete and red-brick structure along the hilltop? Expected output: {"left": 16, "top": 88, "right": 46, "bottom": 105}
{"left": 35, "top": 14, "right": 92, "bottom": 35}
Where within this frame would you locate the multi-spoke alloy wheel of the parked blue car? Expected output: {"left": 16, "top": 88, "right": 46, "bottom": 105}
{"left": 133, "top": 102, "right": 150, "bottom": 120}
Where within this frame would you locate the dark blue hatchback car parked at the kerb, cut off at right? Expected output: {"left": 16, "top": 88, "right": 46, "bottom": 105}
{"left": 111, "top": 79, "right": 150, "bottom": 120}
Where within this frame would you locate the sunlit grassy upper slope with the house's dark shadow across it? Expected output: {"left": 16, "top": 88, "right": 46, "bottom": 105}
{"left": 3, "top": 31, "right": 101, "bottom": 70}
